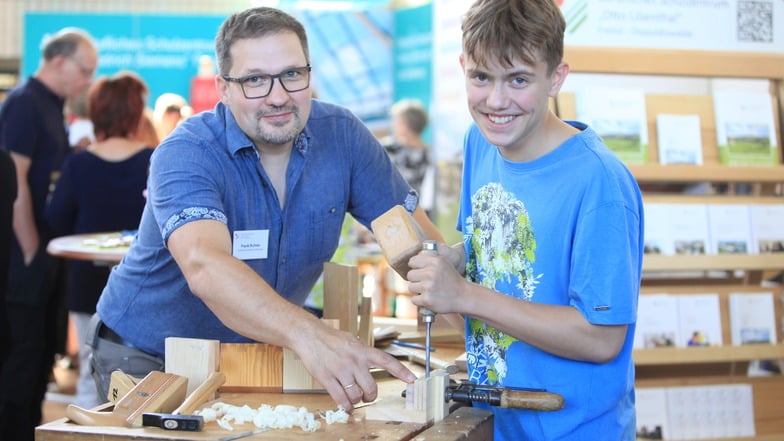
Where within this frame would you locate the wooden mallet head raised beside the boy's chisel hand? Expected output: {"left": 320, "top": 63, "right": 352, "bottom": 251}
{"left": 370, "top": 205, "right": 425, "bottom": 279}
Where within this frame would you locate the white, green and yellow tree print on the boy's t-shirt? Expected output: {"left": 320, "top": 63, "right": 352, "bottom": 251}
{"left": 464, "top": 183, "right": 541, "bottom": 385}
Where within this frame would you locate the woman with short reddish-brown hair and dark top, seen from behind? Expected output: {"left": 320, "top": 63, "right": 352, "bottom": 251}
{"left": 46, "top": 72, "right": 153, "bottom": 409}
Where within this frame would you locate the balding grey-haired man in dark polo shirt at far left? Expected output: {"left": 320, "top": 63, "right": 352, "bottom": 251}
{"left": 0, "top": 28, "right": 98, "bottom": 441}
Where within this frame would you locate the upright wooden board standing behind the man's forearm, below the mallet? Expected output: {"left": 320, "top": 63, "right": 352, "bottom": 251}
{"left": 324, "top": 262, "right": 359, "bottom": 335}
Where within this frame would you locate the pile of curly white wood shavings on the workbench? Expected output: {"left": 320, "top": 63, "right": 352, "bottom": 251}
{"left": 196, "top": 402, "right": 348, "bottom": 432}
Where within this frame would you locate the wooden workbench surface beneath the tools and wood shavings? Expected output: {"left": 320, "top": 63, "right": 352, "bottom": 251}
{"left": 35, "top": 351, "right": 493, "bottom": 441}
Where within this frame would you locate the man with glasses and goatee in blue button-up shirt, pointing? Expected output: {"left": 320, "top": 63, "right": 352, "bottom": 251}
{"left": 93, "top": 8, "right": 442, "bottom": 411}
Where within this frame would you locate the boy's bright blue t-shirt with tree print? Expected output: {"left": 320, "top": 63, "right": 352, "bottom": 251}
{"left": 458, "top": 123, "right": 643, "bottom": 441}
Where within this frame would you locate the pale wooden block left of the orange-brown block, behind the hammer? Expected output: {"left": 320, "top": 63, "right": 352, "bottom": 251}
{"left": 165, "top": 337, "right": 220, "bottom": 400}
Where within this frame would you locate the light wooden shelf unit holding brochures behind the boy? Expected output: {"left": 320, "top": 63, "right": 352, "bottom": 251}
{"left": 554, "top": 46, "right": 784, "bottom": 441}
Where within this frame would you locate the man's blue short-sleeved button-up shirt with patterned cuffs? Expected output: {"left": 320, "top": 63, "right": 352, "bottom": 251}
{"left": 98, "top": 100, "right": 417, "bottom": 355}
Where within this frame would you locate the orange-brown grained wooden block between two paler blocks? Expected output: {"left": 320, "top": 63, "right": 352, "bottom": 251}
{"left": 220, "top": 343, "right": 283, "bottom": 392}
